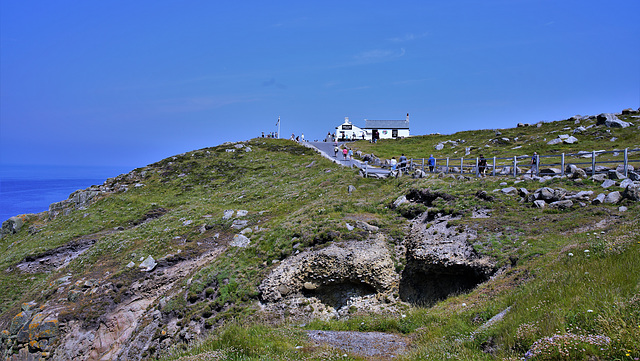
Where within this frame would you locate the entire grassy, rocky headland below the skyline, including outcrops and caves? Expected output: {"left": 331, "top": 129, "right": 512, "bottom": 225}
{"left": 0, "top": 110, "right": 640, "bottom": 360}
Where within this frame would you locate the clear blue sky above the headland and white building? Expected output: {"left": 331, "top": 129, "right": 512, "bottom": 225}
{"left": 0, "top": 0, "right": 640, "bottom": 167}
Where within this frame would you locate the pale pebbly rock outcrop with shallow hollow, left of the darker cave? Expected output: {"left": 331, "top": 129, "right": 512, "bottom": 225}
{"left": 259, "top": 234, "right": 398, "bottom": 315}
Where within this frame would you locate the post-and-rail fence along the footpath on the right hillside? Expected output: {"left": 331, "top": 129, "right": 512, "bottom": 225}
{"left": 409, "top": 148, "right": 640, "bottom": 177}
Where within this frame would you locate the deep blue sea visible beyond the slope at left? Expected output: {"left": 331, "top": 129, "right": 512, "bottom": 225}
{"left": 0, "top": 165, "right": 135, "bottom": 222}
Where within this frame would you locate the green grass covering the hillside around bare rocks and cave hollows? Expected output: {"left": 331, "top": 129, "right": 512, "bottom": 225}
{"left": 0, "top": 111, "right": 640, "bottom": 360}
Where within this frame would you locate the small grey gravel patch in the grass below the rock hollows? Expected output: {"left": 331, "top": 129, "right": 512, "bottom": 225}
{"left": 307, "top": 331, "right": 407, "bottom": 360}
